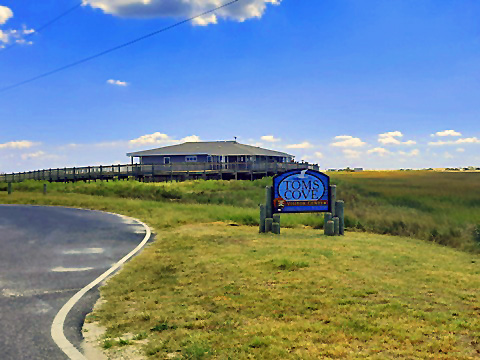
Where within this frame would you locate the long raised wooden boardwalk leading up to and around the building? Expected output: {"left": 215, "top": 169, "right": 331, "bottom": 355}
{"left": 0, "top": 162, "right": 318, "bottom": 182}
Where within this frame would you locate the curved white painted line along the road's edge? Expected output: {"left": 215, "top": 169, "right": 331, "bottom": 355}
{"left": 50, "top": 213, "right": 152, "bottom": 360}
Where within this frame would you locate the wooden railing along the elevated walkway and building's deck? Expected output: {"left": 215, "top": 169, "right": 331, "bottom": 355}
{"left": 0, "top": 162, "right": 318, "bottom": 182}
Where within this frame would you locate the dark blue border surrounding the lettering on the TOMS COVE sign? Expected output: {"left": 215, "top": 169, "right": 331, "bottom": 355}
{"left": 271, "top": 169, "right": 332, "bottom": 214}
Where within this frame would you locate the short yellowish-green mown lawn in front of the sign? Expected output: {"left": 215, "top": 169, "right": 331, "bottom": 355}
{"left": 91, "top": 222, "right": 480, "bottom": 359}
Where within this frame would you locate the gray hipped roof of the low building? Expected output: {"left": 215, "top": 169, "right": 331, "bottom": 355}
{"left": 127, "top": 141, "right": 293, "bottom": 157}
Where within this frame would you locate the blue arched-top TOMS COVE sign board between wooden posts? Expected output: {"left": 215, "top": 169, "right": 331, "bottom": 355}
{"left": 273, "top": 170, "right": 330, "bottom": 213}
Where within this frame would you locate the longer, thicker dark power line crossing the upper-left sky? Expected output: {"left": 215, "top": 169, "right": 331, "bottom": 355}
{"left": 0, "top": 0, "right": 240, "bottom": 93}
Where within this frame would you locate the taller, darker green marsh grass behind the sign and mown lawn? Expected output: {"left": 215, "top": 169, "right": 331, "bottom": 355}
{"left": 0, "top": 171, "right": 480, "bottom": 251}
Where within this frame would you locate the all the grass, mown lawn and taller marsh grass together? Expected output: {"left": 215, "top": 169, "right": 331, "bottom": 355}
{"left": 0, "top": 172, "right": 480, "bottom": 360}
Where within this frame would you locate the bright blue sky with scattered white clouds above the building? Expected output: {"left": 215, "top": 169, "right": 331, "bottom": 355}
{"left": 0, "top": 0, "right": 480, "bottom": 172}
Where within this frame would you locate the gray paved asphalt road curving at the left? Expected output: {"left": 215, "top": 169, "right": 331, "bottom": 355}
{"left": 0, "top": 205, "right": 150, "bottom": 360}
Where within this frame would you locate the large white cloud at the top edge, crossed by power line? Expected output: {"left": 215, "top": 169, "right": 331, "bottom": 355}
{"left": 83, "top": 0, "right": 281, "bottom": 26}
